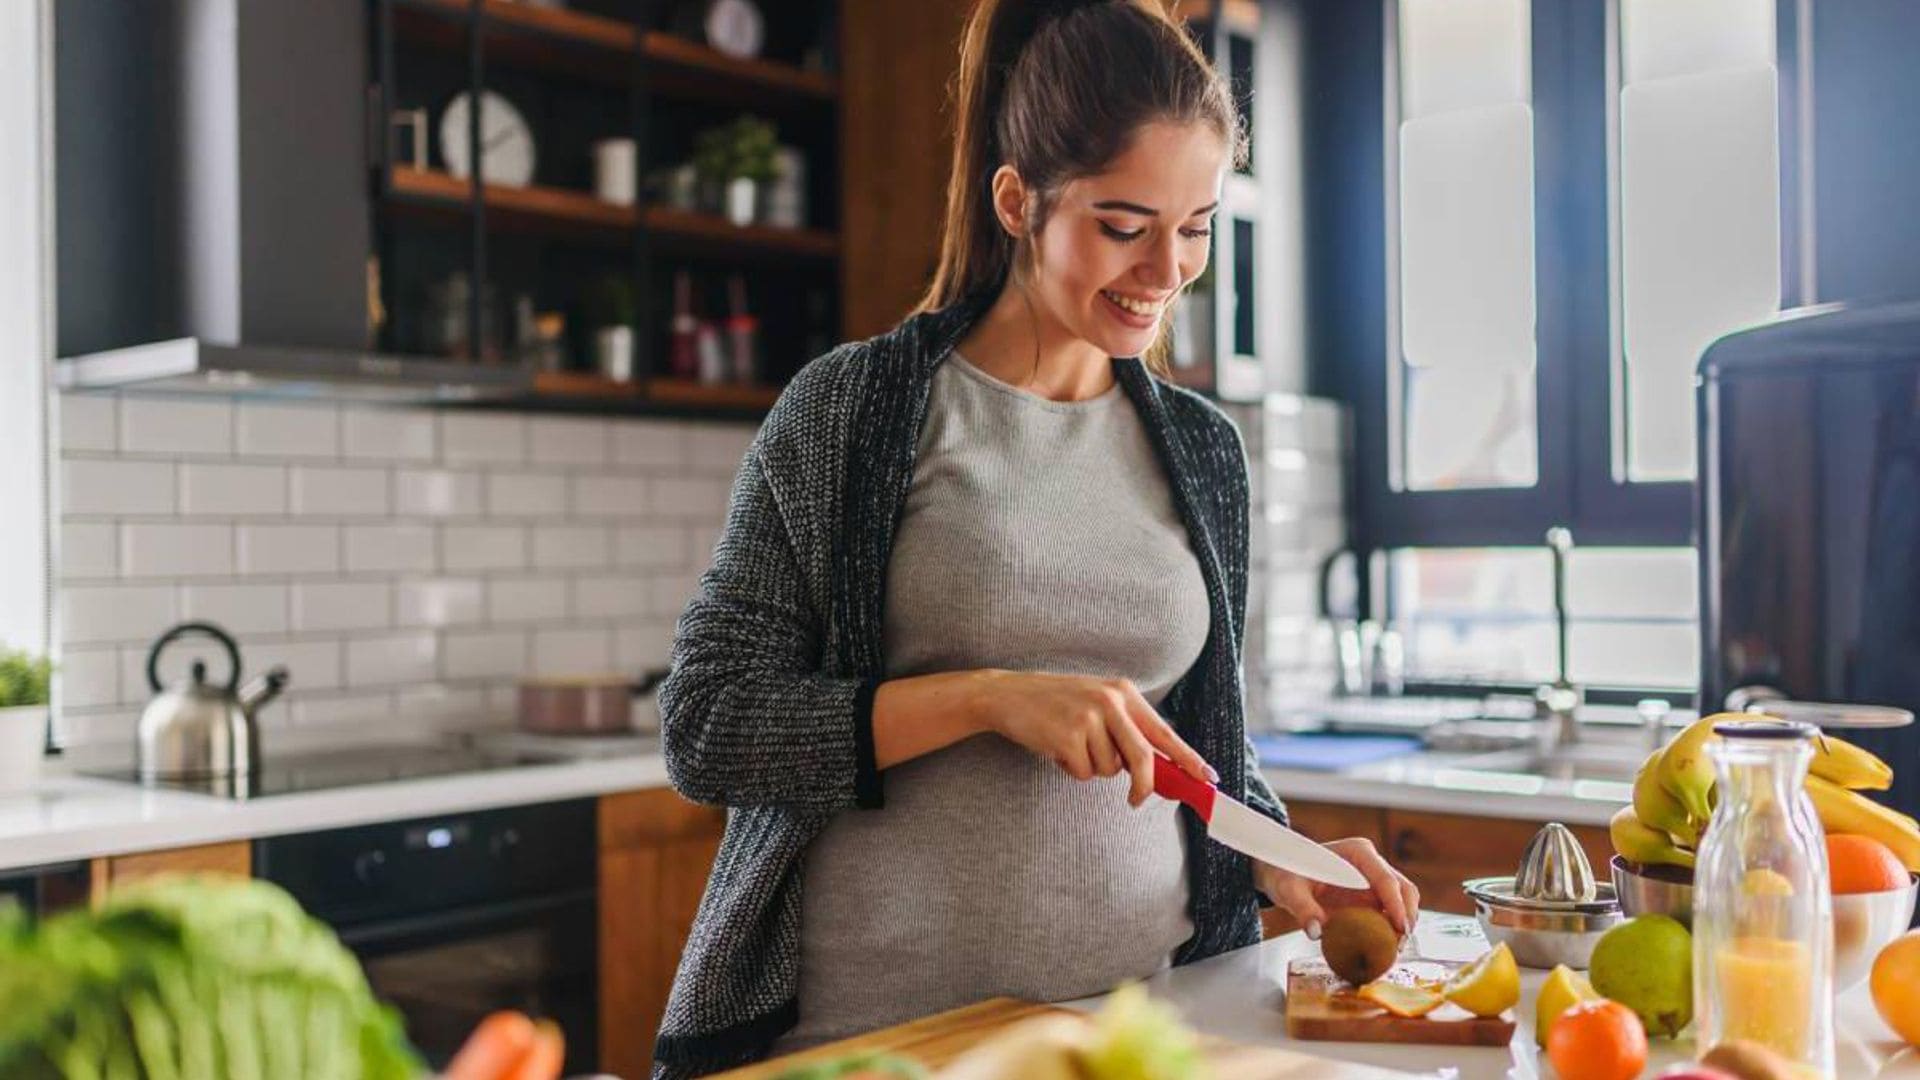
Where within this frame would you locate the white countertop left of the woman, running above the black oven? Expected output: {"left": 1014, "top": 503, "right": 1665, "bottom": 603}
{"left": 0, "top": 734, "right": 666, "bottom": 871}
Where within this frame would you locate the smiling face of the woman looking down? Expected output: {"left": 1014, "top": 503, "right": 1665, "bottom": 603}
{"left": 996, "top": 123, "right": 1227, "bottom": 356}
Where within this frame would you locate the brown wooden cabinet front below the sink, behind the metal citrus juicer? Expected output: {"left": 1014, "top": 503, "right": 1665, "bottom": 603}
{"left": 1384, "top": 809, "right": 1613, "bottom": 915}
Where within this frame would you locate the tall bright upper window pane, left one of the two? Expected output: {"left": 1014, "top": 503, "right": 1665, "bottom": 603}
{"left": 1390, "top": 0, "right": 1538, "bottom": 490}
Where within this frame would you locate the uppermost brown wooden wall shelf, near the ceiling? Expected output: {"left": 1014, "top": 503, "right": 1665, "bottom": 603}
{"left": 396, "top": 0, "right": 839, "bottom": 110}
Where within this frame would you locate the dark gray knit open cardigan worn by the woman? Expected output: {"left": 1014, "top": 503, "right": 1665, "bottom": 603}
{"left": 655, "top": 304, "right": 1286, "bottom": 1080}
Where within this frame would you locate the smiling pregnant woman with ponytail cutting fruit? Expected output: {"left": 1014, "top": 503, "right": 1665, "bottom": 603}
{"left": 655, "top": 0, "right": 1417, "bottom": 1078}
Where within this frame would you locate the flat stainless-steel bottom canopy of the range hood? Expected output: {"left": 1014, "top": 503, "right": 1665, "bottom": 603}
{"left": 54, "top": 338, "right": 534, "bottom": 404}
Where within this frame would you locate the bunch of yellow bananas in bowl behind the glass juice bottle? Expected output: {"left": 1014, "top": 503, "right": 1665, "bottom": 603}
{"left": 1609, "top": 713, "right": 1920, "bottom": 871}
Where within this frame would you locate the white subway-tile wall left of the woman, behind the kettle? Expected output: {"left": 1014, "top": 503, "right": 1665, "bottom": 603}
{"left": 60, "top": 394, "right": 753, "bottom": 746}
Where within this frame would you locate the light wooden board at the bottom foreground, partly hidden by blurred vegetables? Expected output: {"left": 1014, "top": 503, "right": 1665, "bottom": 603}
{"left": 708, "top": 997, "right": 1407, "bottom": 1080}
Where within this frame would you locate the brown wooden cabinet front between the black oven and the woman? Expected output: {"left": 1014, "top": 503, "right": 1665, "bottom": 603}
{"left": 599, "top": 788, "right": 726, "bottom": 1076}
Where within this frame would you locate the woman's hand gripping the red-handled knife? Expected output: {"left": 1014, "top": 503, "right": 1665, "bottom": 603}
{"left": 972, "top": 671, "right": 1219, "bottom": 807}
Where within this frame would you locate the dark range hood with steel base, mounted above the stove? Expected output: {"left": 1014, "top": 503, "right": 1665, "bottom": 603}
{"left": 54, "top": 0, "right": 532, "bottom": 402}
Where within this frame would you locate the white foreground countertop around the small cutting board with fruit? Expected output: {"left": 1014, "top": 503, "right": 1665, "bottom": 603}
{"left": 1068, "top": 913, "right": 1920, "bottom": 1080}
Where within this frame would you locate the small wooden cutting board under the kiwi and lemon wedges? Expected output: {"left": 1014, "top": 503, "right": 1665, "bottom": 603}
{"left": 1286, "top": 957, "right": 1513, "bottom": 1045}
